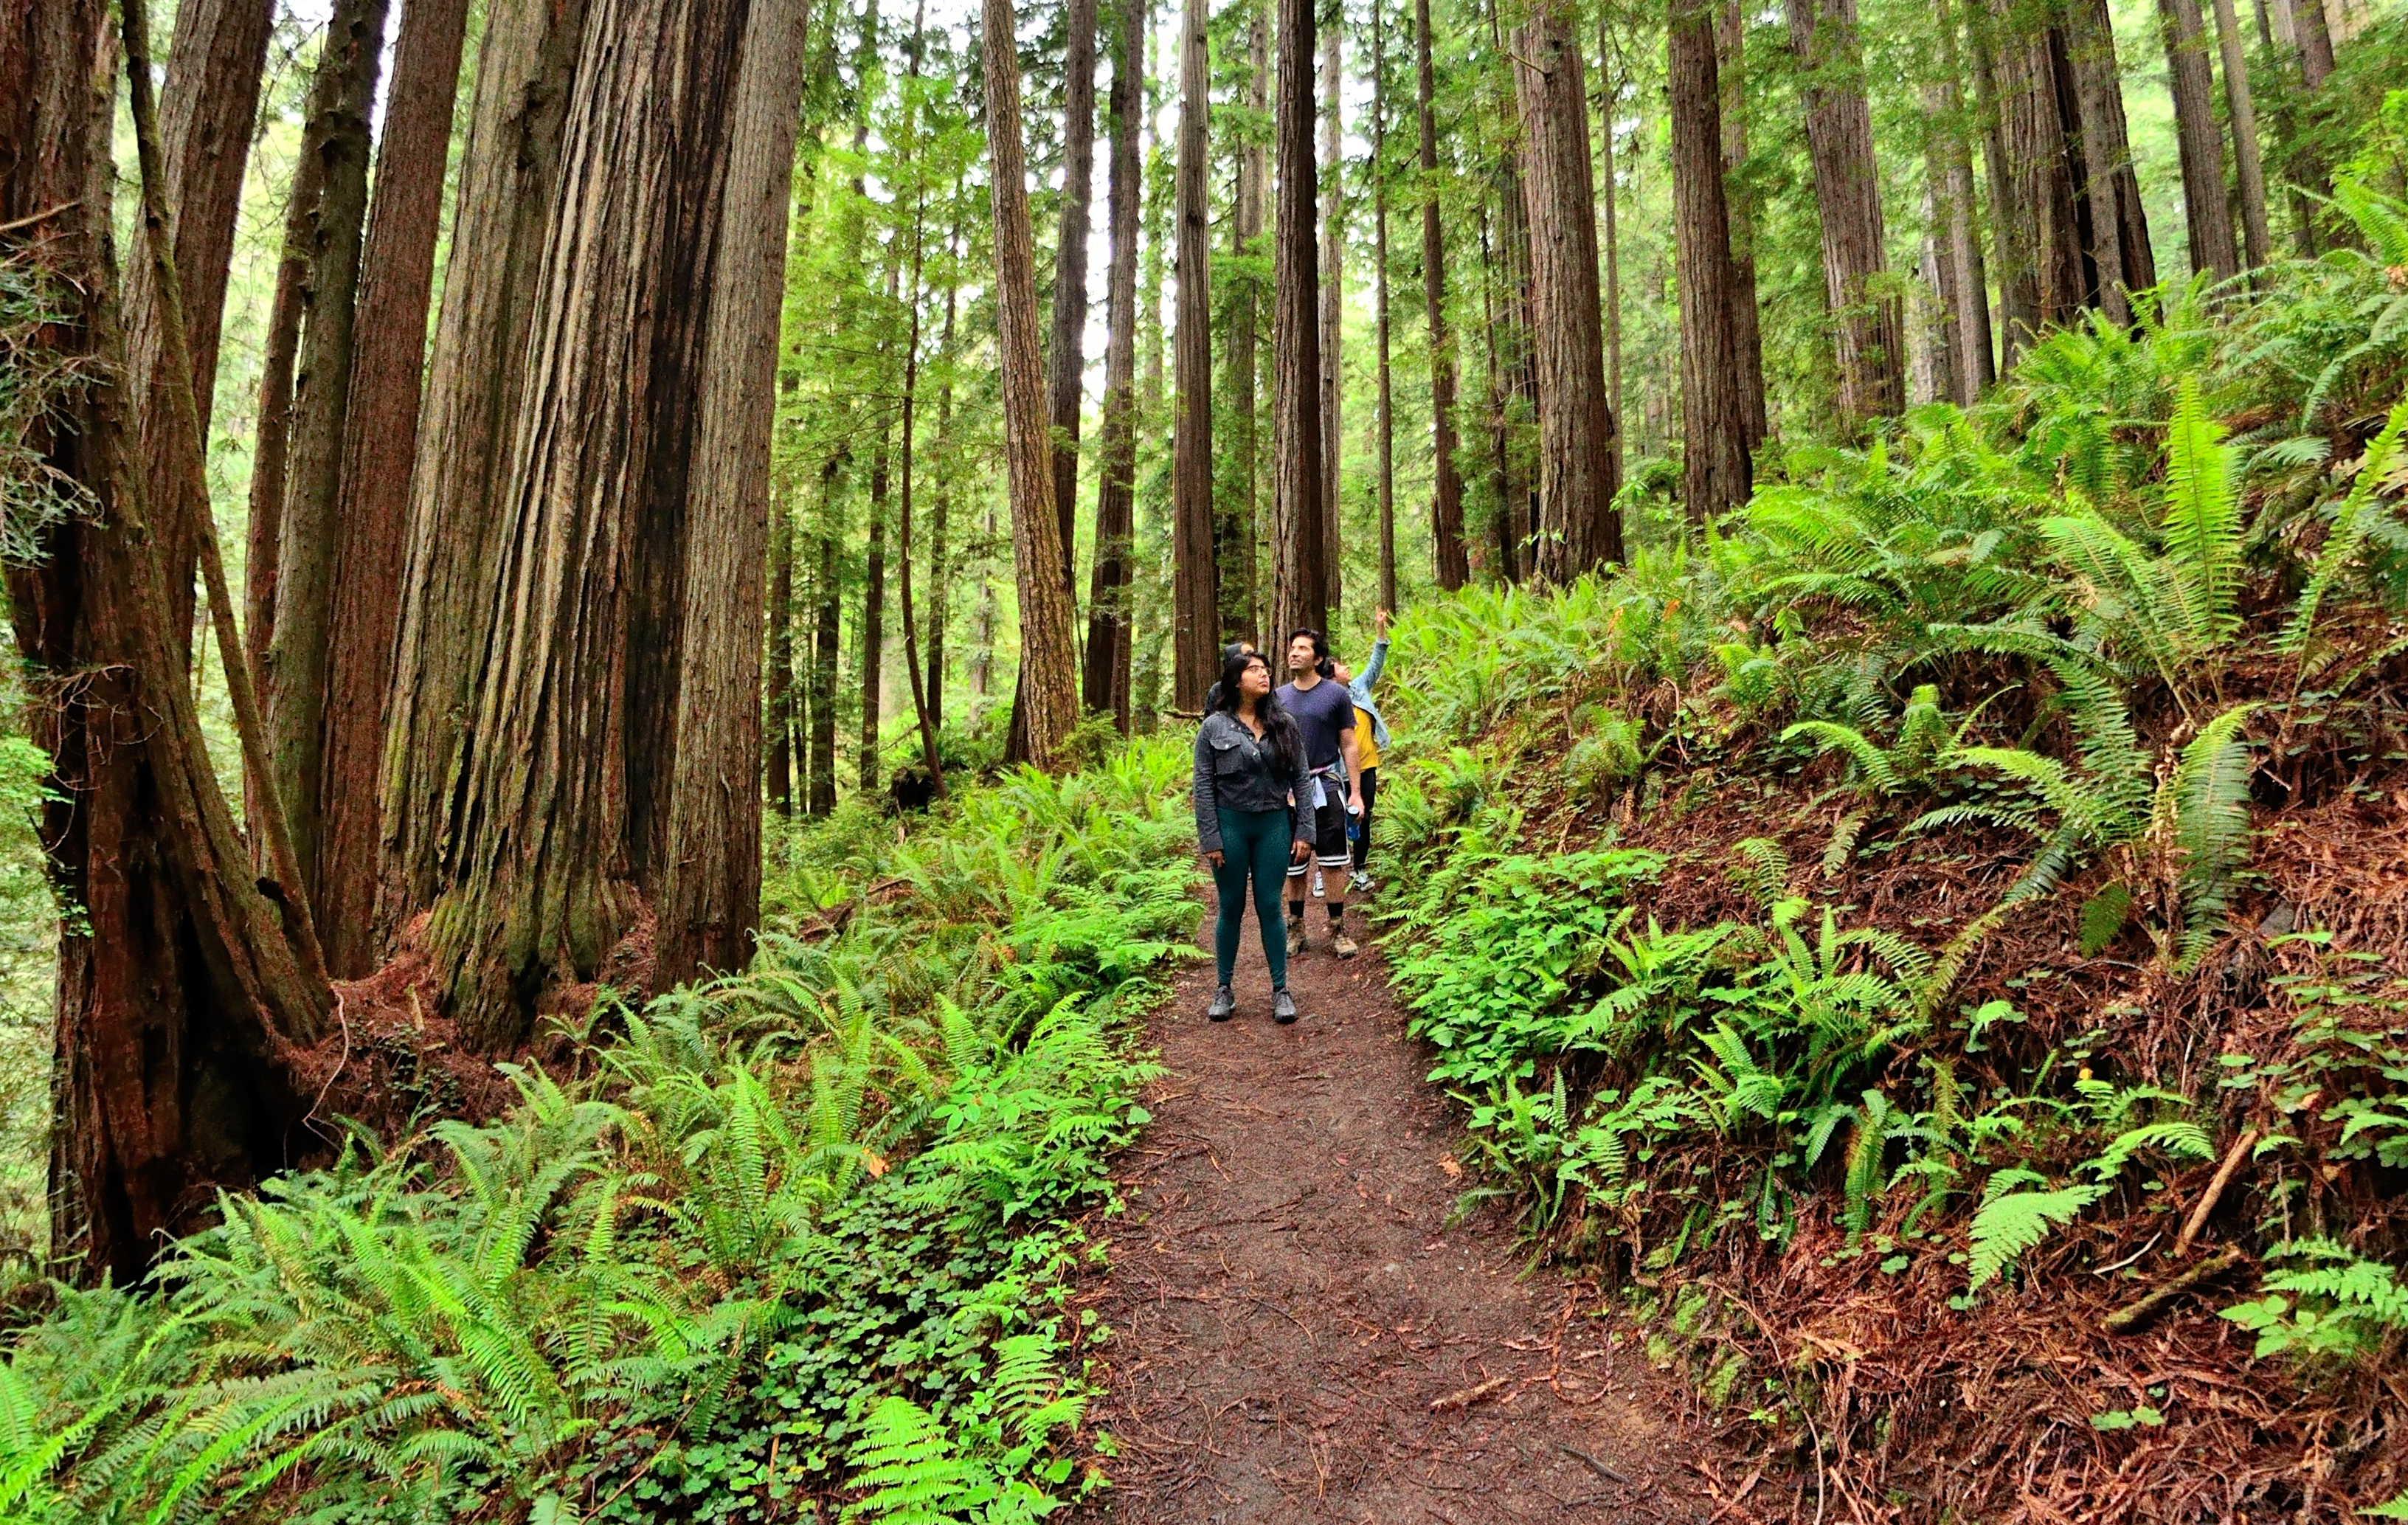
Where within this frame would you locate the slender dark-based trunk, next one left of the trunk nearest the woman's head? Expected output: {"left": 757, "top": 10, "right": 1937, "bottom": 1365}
{"left": 1084, "top": 0, "right": 1146, "bottom": 735}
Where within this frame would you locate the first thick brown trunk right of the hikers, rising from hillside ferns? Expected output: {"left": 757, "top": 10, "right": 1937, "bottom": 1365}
{"left": 1512, "top": 0, "right": 1623, "bottom": 583}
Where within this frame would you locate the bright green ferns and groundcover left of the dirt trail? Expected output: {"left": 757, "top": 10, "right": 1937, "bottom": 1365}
{"left": 0, "top": 744, "right": 1194, "bottom": 1525}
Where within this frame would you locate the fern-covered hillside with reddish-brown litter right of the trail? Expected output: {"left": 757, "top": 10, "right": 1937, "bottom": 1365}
{"left": 1377, "top": 185, "right": 2408, "bottom": 1518}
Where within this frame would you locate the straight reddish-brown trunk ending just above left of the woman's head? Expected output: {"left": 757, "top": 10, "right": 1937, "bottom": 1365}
{"left": 1170, "top": 0, "right": 1221, "bottom": 713}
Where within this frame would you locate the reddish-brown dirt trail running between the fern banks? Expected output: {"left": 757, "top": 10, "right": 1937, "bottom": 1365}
{"left": 1086, "top": 901, "right": 1712, "bottom": 1525}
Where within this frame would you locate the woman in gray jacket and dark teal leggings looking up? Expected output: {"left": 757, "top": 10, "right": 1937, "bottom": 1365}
{"left": 1194, "top": 651, "right": 1312, "bottom": 1024}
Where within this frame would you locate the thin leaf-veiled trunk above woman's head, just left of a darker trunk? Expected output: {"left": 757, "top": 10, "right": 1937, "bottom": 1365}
{"left": 1206, "top": 2, "right": 1271, "bottom": 640}
